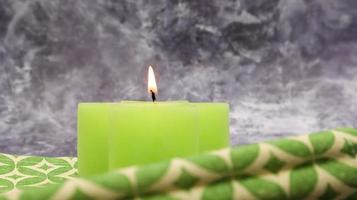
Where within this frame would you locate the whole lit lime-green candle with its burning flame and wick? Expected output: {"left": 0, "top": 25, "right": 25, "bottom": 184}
{"left": 78, "top": 67, "right": 229, "bottom": 176}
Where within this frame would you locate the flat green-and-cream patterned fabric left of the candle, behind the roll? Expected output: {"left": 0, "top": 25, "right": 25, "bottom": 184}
{"left": 0, "top": 154, "right": 77, "bottom": 193}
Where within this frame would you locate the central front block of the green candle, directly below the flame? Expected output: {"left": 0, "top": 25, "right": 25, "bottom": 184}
{"left": 109, "top": 102, "right": 199, "bottom": 169}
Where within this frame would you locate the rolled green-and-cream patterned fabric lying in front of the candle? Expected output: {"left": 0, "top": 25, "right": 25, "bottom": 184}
{"left": 1, "top": 128, "right": 357, "bottom": 200}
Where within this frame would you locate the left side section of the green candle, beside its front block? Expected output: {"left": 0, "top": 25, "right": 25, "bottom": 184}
{"left": 77, "top": 103, "right": 112, "bottom": 176}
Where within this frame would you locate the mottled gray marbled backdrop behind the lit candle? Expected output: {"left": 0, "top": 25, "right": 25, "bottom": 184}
{"left": 0, "top": 0, "right": 357, "bottom": 156}
